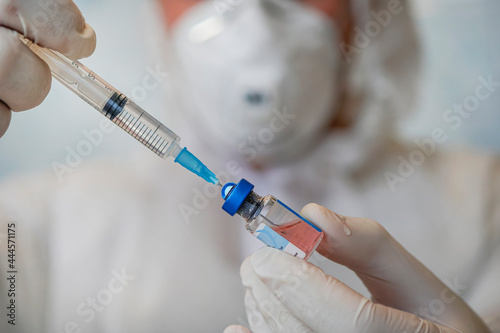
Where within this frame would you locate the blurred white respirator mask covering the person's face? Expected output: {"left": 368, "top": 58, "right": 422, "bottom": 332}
{"left": 173, "top": 0, "right": 340, "bottom": 164}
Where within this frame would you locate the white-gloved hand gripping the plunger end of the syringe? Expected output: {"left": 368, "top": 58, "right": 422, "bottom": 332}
{"left": 0, "top": 0, "right": 96, "bottom": 137}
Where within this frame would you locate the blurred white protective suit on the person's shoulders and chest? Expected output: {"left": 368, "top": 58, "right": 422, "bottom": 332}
{"left": 0, "top": 0, "right": 500, "bottom": 333}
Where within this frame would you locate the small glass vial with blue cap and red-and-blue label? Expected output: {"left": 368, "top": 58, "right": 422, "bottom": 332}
{"left": 221, "top": 179, "right": 323, "bottom": 259}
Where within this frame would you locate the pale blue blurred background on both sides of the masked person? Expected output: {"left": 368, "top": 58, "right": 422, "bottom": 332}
{"left": 0, "top": 0, "right": 500, "bottom": 178}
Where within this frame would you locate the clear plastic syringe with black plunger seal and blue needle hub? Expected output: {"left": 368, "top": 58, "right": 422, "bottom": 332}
{"left": 20, "top": 37, "right": 219, "bottom": 184}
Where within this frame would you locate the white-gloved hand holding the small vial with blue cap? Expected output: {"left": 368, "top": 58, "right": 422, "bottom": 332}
{"left": 224, "top": 204, "right": 490, "bottom": 333}
